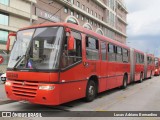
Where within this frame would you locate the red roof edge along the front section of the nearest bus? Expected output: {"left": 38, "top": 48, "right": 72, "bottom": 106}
{"left": 20, "top": 23, "right": 130, "bottom": 49}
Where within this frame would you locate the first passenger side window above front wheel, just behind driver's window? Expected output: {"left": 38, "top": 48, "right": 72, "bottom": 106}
{"left": 86, "top": 36, "right": 99, "bottom": 60}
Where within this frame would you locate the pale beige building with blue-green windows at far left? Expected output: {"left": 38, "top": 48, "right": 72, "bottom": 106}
{"left": 0, "top": 0, "right": 37, "bottom": 73}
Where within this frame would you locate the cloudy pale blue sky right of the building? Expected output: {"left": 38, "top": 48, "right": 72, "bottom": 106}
{"left": 124, "top": 0, "right": 160, "bottom": 57}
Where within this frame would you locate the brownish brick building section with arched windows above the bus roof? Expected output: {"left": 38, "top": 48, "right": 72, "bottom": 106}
{"left": 32, "top": 0, "right": 128, "bottom": 43}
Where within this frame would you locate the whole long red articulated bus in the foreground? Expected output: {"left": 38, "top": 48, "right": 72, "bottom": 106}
{"left": 5, "top": 23, "right": 152, "bottom": 105}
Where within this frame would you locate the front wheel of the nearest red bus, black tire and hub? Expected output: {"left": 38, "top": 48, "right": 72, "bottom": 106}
{"left": 85, "top": 80, "right": 97, "bottom": 102}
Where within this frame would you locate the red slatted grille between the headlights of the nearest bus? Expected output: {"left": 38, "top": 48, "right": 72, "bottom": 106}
{"left": 12, "top": 81, "right": 38, "bottom": 98}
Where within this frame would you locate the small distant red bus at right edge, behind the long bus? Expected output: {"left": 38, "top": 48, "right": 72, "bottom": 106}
{"left": 154, "top": 57, "right": 160, "bottom": 76}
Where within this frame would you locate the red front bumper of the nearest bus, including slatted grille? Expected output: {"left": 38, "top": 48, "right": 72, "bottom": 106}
{"left": 5, "top": 80, "right": 60, "bottom": 105}
